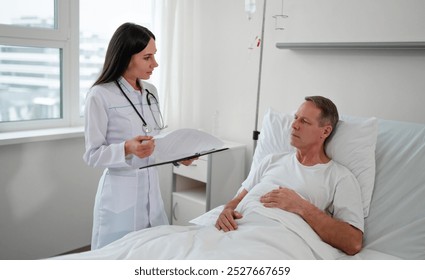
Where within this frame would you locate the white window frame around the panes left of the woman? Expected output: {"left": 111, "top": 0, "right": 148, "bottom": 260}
{"left": 0, "top": 0, "right": 84, "bottom": 134}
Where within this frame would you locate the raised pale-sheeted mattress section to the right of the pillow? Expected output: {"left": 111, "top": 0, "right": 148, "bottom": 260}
{"left": 364, "top": 120, "right": 425, "bottom": 259}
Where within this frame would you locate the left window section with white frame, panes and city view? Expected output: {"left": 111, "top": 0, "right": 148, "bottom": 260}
{"left": 0, "top": 0, "right": 71, "bottom": 132}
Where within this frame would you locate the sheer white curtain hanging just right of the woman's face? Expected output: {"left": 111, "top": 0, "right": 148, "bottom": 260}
{"left": 155, "top": 0, "right": 199, "bottom": 129}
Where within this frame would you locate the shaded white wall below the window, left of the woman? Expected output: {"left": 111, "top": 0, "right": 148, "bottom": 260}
{"left": 0, "top": 137, "right": 101, "bottom": 259}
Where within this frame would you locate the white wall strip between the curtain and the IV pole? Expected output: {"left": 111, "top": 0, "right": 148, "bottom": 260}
{"left": 194, "top": 0, "right": 261, "bottom": 161}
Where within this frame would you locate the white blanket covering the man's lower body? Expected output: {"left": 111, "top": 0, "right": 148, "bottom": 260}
{"left": 53, "top": 196, "right": 345, "bottom": 260}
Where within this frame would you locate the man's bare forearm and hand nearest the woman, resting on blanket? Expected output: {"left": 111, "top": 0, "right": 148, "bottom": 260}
{"left": 215, "top": 189, "right": 248, "bottom": 232}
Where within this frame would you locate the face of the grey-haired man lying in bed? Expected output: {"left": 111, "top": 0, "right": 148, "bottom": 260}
{"left": 291, "top": 101, "right": 325, "bottom": 149}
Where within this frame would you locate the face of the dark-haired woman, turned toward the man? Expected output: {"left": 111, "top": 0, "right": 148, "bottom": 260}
{"left": 123, "top": 39, "right": 158, "bottom": 81}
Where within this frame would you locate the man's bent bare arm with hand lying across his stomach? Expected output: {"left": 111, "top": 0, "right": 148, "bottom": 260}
{"left": 261, "top": 187, "right": 363, "bottom": 255}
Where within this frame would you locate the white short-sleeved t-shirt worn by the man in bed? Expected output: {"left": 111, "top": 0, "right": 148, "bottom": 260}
{"left": 242, "top": 153, "right": 364, "bottom": 231}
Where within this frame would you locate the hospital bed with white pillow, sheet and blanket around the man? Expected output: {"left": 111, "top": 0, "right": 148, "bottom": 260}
{"left": 54, "top": 108, "right": 425, "bottom": 259}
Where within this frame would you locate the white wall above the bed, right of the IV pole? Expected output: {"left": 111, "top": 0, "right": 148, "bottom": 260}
{"left": 262, "top": 0, "right": 425, "bottom": 122}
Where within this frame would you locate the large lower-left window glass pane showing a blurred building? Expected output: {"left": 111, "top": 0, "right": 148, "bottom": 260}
{"left": 0, "top": 45, "right": 62, "bottom": 122}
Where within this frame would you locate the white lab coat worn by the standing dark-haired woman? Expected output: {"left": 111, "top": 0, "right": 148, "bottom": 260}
{"left": 83, "top": 77, "right": 168, "bottom": 249}
